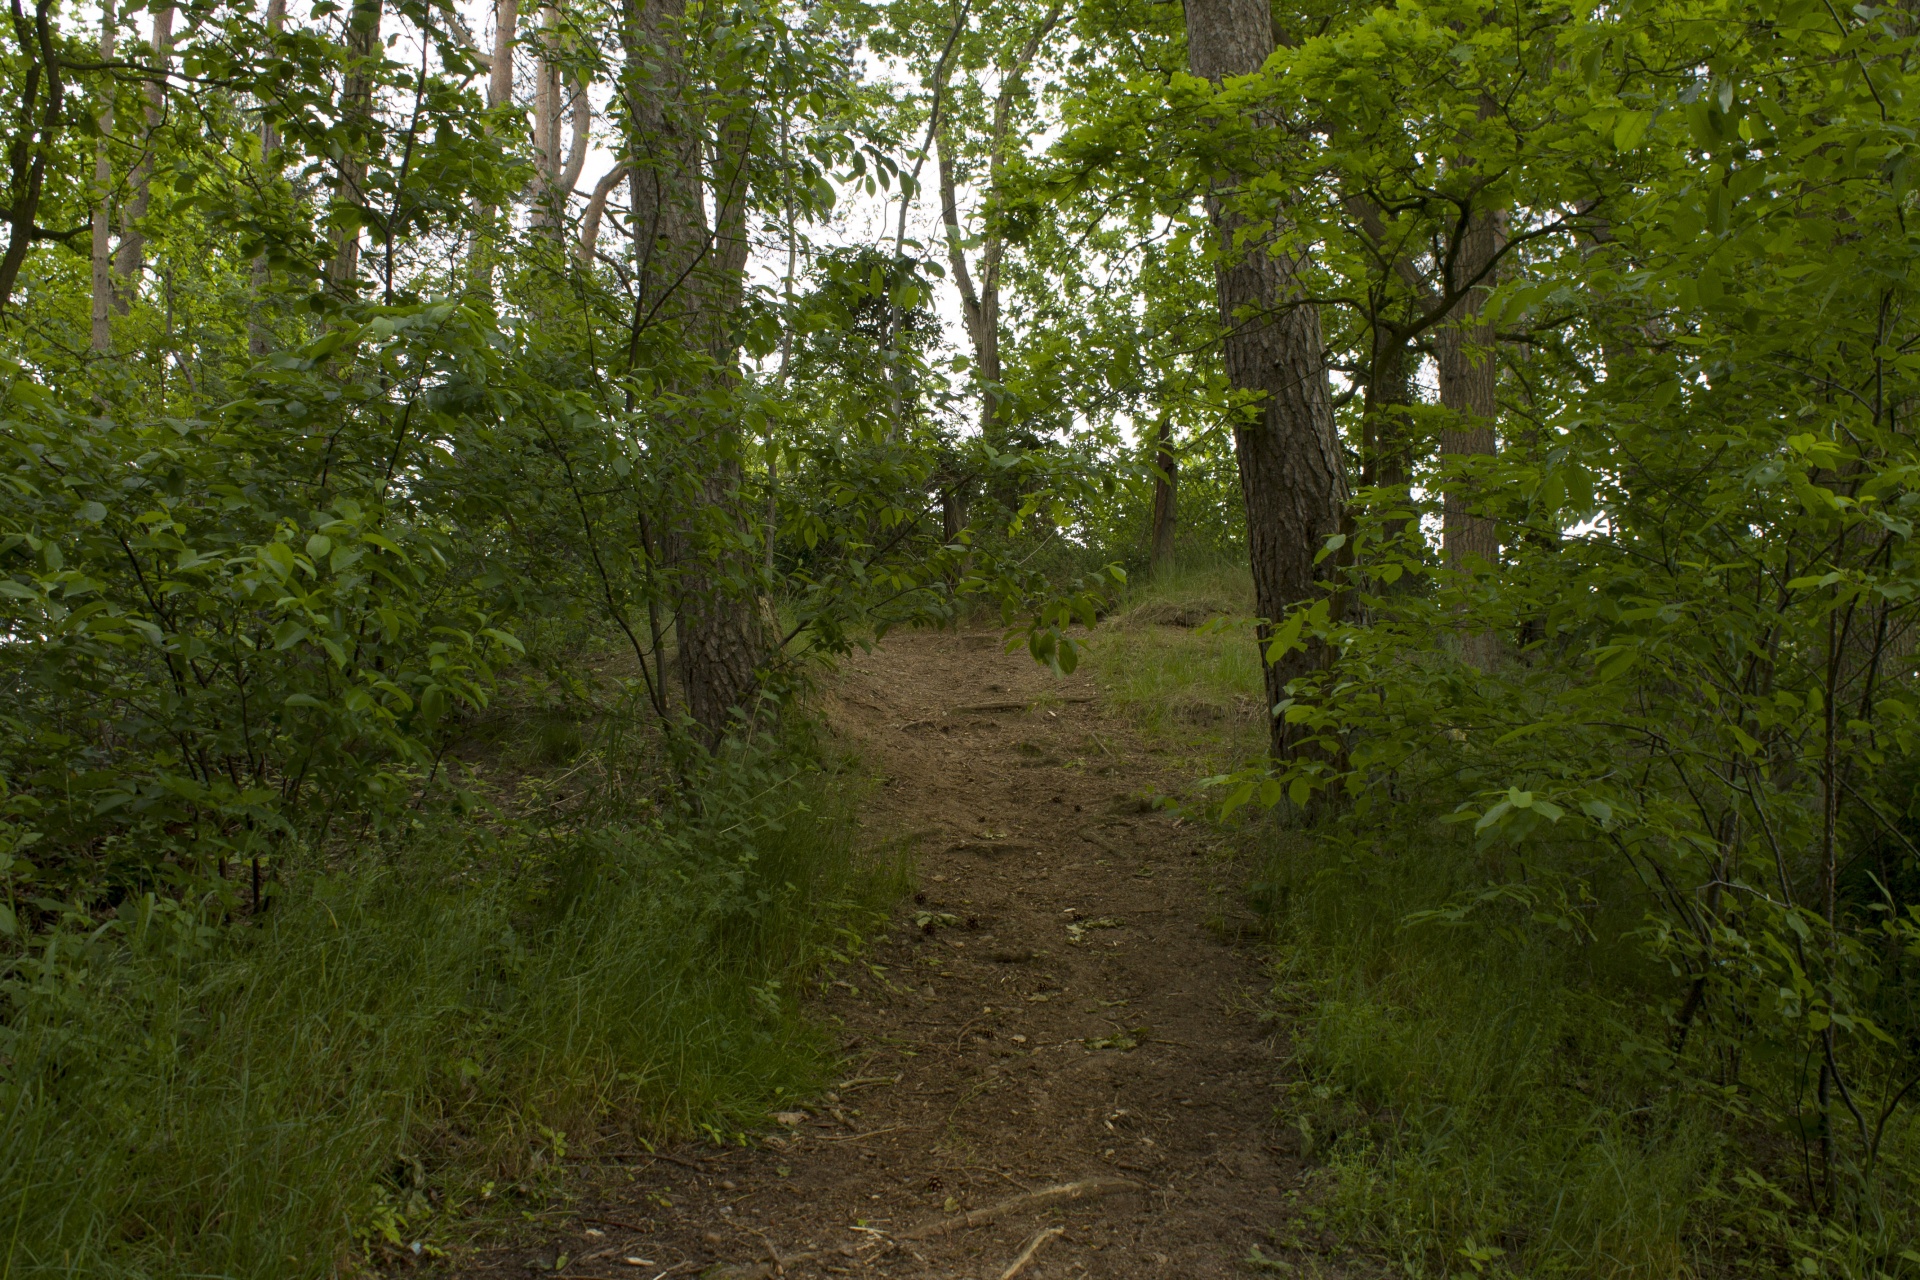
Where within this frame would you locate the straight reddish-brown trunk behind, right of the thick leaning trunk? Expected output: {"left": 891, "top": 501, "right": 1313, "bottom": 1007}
{"left": 1436, "top": 211, "right": 1500, "bottom": 668}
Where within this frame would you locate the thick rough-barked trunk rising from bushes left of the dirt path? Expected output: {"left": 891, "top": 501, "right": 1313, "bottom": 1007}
{"left": 622, "top": 0, "right": 768, "bottom": 745}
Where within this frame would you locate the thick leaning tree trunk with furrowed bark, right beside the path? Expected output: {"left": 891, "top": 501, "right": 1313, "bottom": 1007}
{"left": 1187, "top": 0, "right": 1348, "bottom": 756}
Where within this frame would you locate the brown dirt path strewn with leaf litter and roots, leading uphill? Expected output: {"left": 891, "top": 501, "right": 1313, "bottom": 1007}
{"left": 472, "top": 633, "right": 1298, "bottom": 1280}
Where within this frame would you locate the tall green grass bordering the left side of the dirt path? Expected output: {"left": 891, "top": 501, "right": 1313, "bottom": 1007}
{"left": 0, "top": 736, "right": 897, "bottom": 1280}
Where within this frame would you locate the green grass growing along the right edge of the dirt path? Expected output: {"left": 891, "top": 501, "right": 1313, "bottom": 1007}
{"left": 1091, "top": 566, "right": 1732, "bottom": 1278}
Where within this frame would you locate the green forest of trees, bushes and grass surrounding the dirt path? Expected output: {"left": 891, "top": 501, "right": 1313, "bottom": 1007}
{"left": 0, "top": 0, "right": 1920, "bottom": 1280}
